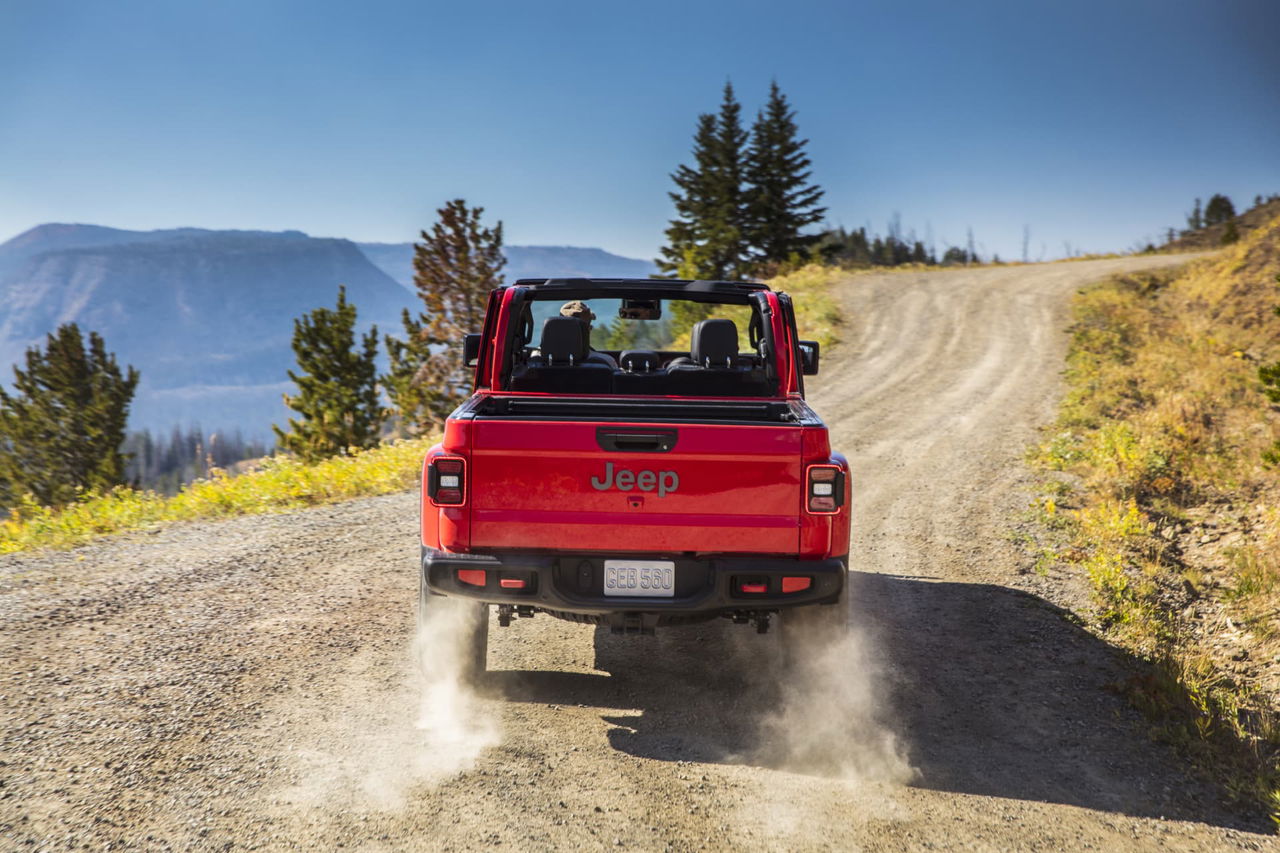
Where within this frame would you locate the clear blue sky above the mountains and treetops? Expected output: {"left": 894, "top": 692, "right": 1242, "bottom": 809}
{"left": 0, "top": 0, "right": 1280, "bottom": 259}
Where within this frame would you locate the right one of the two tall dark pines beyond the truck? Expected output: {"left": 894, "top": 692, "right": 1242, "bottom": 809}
{"left": 746, "top": 81, "right": 827, "bottom": 264}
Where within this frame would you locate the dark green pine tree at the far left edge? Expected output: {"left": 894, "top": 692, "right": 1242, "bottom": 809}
{"left": 0, "top": 323, "right": 138, "bottom": 506}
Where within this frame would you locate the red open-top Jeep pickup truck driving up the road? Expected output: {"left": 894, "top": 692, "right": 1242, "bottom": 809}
{"left": 419, "top": 279, "right": 851, "bottom": 671}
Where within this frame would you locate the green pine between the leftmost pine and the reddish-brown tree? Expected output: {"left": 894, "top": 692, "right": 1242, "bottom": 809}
{"left": 271, "top": 287, "right": 388, "bottom": 461}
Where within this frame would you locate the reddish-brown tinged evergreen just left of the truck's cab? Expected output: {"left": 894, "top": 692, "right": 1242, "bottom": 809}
{"left": 383, "top": 199, "right": 507, "bottom": 434}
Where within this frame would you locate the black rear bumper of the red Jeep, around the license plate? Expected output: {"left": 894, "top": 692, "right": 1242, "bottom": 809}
{"left": 422, "top": 548, "right": 846, "bottom": 621}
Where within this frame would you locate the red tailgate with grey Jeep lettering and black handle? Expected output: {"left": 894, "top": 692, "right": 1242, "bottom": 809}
{"left": 470, "top": 418, "right": 801, "bottom": 555}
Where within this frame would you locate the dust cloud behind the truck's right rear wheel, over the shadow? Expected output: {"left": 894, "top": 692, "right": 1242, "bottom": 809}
{"left": 760, "top": 603, "right": 915, "bottom": 784}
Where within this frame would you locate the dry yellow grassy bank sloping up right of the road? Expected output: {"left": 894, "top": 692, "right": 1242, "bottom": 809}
{"left": 1036, "top": 219, "right": 1280, "bottom": 816}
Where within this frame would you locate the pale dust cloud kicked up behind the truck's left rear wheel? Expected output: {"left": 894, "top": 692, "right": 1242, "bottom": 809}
{"left": 285, "top": 598, "right": 500, "bottom": 809}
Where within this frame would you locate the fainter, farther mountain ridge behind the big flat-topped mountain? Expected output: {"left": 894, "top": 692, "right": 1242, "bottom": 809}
{"left": 356, "top": 243, "right": 658, "bottom": 291}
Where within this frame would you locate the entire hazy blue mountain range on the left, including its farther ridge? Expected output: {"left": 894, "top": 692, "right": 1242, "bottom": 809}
{"left": 0, "top": 224, "right": 653, "bottom": 438}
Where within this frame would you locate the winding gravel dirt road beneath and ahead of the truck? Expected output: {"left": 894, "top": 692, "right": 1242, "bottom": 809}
{"left": 0, "top": 259, "right": 1274, "bottom": 850}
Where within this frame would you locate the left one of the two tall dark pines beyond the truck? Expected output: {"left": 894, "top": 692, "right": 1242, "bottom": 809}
{"left": 657, "top": 83, "right": 750, "bottom": 279}
